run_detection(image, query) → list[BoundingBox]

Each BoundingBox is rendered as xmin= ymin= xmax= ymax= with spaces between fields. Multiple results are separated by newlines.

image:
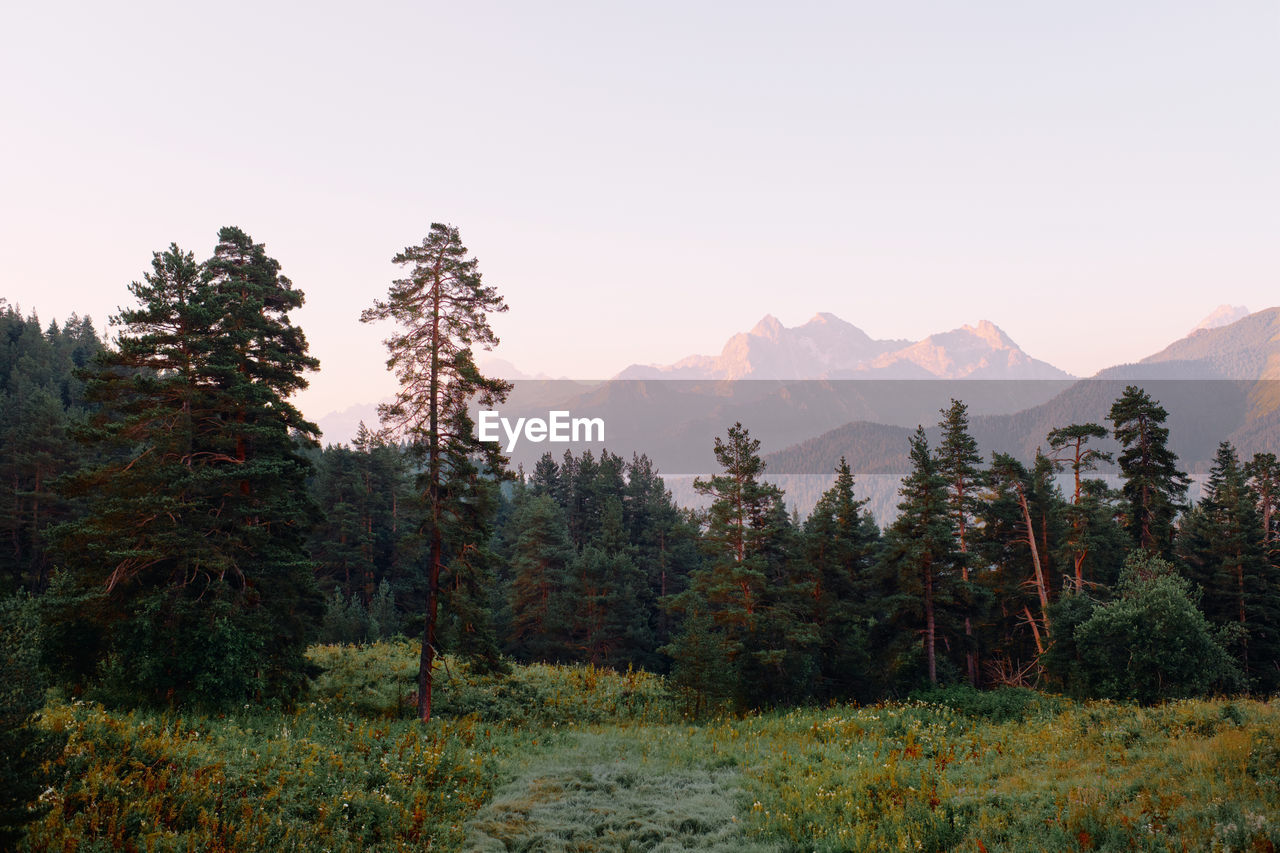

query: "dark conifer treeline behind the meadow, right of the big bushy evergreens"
xmin=296 ymin=387 xmax=1280 ymax=706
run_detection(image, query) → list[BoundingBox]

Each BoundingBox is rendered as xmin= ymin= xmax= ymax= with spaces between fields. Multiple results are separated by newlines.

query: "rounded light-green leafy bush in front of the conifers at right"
xmin=1074 ymin=552 xmax=1243 ymax=702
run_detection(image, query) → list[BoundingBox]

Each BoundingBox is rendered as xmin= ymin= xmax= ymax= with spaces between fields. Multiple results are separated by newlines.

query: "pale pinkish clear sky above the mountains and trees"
xmin=0 ymin=0 xmax=1280 ymax=418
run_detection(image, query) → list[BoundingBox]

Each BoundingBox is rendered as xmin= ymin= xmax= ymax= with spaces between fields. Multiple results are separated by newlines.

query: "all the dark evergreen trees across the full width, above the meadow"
xmin=0 ymin=225 xmax=1280 ymax=829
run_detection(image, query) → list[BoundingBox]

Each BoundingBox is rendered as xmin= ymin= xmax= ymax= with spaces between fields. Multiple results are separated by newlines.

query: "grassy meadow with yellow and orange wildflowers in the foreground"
xmin=27 ymin=643 xmax=1280 ymax=853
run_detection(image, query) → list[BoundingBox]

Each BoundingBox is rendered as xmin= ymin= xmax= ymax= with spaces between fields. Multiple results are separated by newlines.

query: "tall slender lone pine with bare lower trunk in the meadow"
xmin=360 ymin=223 xmax=511 ymax=721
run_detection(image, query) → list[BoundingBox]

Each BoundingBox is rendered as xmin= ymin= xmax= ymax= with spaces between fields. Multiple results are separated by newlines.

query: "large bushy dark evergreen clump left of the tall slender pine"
xmin=52 ymin=228 xmax=320 ymax=703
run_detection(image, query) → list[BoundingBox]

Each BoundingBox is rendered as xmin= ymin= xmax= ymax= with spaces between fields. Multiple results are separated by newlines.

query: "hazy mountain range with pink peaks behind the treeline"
xmin=312 ymin=306 xmax=1280 ymax=511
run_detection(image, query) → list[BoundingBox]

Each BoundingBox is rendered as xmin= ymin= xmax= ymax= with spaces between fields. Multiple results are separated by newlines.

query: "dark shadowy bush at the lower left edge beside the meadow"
xmin=0 ymin=596 xmax=63 ymax=849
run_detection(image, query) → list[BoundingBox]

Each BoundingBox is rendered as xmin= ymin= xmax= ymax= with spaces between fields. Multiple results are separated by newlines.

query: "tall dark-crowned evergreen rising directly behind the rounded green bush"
xmin=1108 ymin=386 xmax=1188 ymax=558
